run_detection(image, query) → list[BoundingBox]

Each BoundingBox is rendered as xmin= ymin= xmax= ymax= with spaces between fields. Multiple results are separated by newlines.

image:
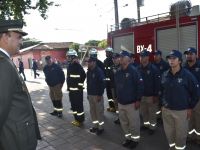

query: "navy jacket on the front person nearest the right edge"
xmin=161 ymin=68 xmax=199 ymax=110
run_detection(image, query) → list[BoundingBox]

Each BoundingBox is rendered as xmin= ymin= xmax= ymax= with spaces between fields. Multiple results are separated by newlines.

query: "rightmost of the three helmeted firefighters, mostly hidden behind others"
xmin=104 ymin=47 xmax=116 ymax=112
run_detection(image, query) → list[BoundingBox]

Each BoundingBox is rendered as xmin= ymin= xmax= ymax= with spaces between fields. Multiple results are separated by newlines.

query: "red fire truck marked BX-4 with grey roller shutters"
xmin=107 ymin=5 xmax=200 ymax=60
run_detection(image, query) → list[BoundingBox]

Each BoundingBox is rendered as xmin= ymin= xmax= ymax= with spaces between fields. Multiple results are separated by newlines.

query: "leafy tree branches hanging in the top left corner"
xmin=0 ymin=0 xmax=59 ymax=20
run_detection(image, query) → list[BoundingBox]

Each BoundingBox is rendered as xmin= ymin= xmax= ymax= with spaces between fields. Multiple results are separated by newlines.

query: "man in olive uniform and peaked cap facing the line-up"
xmin=0 ymin=20 xmax=41 ymax=150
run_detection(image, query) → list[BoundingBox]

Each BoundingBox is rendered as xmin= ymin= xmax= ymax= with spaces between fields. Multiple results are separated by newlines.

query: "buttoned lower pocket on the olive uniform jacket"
xmin=16 ymin=121 xmax=37 ymax=150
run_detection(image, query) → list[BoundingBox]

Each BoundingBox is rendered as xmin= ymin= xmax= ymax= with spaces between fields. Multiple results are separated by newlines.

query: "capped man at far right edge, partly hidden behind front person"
xmin=184 ymin=47 xmax=200 ymax=145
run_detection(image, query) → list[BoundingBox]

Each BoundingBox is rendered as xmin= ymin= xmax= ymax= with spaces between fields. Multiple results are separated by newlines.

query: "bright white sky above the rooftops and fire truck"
xmin=24 ymin=0 xmax=200 ymax=44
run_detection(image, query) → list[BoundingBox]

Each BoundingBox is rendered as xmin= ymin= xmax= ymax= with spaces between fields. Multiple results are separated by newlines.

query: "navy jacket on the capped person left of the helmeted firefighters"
xmin=43 ymin=63 xmax=65 ymax=87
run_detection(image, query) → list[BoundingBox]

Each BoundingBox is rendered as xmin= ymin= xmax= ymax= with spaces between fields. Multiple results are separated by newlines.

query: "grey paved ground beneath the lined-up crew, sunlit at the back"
xmin=22 ymin=70 xmax=199 ymax=150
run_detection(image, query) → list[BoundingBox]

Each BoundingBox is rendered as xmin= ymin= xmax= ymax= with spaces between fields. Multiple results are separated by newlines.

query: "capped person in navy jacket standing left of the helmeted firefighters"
xmin=43 ymin=56 xmax=65 ymax=118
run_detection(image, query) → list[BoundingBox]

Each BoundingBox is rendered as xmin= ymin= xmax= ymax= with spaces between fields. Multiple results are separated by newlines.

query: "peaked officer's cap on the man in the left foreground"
xmin=0 ymin=20 xmax=28 ymax=36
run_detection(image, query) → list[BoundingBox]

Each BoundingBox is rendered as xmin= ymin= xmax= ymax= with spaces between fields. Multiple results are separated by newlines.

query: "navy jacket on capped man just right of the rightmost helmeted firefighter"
xmin=115 ymin=64 xmax=144 ymax=105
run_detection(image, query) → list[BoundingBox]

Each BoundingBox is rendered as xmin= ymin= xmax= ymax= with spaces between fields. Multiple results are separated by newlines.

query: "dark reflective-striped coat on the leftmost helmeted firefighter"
xmin=67 ymin=62 xmax=86 ymax=91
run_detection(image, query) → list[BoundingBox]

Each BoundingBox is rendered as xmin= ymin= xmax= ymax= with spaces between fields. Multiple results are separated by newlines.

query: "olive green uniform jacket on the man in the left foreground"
xmin=0 ymin=51 xmax=41 ymax=150
